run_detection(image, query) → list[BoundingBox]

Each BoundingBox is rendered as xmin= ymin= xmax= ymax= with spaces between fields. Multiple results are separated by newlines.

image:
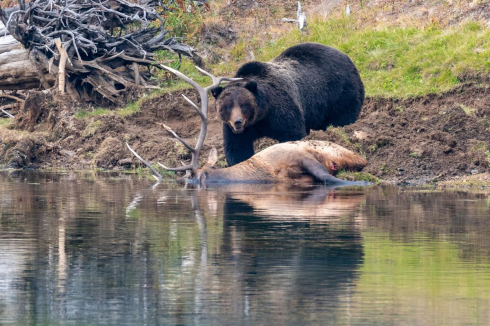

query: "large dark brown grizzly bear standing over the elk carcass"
xmin=212 ymin=43 xmax=364 ymax=166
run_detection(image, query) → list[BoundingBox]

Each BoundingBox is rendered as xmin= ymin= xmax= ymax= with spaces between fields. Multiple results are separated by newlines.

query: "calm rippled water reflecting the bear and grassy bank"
xmin=0 ymin=172 xmax=490 ymax=325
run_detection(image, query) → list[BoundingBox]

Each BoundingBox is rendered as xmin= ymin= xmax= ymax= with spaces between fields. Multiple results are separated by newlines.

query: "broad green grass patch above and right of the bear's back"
xmin=249 ymin=19 xmax=490 ymax=98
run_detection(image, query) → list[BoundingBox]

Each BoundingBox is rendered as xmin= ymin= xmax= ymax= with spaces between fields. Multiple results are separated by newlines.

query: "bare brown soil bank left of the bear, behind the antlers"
xmin=11 ymin=90 xmax=229 ymax=169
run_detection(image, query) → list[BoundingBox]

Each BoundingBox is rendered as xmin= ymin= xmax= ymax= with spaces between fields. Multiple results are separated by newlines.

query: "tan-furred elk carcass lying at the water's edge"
xmin=195 ymin=141 xmax=367 ymax=184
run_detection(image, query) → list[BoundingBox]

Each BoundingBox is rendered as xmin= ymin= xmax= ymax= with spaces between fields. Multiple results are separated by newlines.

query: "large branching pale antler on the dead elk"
xmin=126 ymin=65 xmax=241 ymax=181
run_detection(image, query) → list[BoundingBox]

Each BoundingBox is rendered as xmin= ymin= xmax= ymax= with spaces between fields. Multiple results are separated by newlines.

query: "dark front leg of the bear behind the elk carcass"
xmin=223 ymin=123 xmax=257 ymax=166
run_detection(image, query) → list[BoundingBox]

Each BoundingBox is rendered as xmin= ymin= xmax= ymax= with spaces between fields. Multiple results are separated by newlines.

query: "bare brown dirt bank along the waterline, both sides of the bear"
xmin=0 ymin=85 xmax=490 ymax=184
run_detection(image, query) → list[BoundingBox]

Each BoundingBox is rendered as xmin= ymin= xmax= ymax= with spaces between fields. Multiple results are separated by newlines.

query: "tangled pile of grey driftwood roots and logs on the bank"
xmin=0 ymin=0 xmax=201 ymax=106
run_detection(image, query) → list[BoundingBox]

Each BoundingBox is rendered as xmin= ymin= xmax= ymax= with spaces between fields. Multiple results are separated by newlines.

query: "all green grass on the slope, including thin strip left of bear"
xmin=76 ymin=9 xmax=490 ymax=118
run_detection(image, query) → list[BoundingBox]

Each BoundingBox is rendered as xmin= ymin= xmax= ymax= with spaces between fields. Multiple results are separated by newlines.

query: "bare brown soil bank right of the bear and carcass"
xmin=309 ymin=85 xmax=490 ymax=184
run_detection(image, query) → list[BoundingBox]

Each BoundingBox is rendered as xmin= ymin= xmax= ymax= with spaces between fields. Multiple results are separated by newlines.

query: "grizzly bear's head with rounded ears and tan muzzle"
xmin=211 ymin=80 xmax=258 ymax=134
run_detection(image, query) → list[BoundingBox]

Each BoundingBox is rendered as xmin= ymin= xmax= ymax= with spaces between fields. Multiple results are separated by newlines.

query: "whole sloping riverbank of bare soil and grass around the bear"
xmin=0 ymin=1 xmax=490 ymax=187
